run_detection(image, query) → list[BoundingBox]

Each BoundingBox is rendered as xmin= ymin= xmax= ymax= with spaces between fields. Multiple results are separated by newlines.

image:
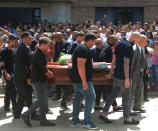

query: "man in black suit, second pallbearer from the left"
xmin=14 ymin=32 xmax=38 ymax=119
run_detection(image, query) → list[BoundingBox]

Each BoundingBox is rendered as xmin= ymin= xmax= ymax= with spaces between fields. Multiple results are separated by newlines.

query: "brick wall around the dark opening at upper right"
xmin=71 ymin=0 xmax=158 ymax=23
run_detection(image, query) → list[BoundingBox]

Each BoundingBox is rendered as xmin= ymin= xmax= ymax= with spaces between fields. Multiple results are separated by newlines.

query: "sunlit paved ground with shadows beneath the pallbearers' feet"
xmin=0 ymin=93 xmax=158 ymax=131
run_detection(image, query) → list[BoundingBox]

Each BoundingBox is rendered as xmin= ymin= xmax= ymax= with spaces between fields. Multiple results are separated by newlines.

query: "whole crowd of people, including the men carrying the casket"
xmin=0 ymin=18 xmax=158 ymax=129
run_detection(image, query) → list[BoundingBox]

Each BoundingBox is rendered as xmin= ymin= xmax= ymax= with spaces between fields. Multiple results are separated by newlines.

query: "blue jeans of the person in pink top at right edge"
xmin=150 ymin=65 xmax=158 ymax=87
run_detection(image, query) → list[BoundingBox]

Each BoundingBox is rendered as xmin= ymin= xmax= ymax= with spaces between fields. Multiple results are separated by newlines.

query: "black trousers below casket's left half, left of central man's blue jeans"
xmin=56 ymin=86 xmax=72 ymax=106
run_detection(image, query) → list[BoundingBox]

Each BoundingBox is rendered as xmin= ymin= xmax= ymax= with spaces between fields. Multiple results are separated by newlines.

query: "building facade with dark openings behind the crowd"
xmin=0 ymin=0 xmax=158 ymax=24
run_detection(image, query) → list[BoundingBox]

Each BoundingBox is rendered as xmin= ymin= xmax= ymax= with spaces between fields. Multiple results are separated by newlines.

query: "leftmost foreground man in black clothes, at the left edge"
xmin=0 ymin=35 xmax=19 ymax=112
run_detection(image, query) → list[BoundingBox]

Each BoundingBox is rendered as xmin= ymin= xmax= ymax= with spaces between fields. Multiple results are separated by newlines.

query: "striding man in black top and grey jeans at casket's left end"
xmin=22 ymin=37 xmax=55 ymax=127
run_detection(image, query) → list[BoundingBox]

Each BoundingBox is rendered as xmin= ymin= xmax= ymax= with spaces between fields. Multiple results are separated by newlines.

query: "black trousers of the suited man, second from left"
xmin=14 ymin=81 xmax=32 ymax=117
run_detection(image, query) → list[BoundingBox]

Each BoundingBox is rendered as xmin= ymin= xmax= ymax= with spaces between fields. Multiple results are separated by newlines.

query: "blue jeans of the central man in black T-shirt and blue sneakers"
xmin=72 ymin=81 xmax=96 ymax=124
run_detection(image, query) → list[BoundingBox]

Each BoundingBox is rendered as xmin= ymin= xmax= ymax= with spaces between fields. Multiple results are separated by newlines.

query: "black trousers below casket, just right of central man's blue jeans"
xmin=94 ymin=86 xmax=117 ymax=106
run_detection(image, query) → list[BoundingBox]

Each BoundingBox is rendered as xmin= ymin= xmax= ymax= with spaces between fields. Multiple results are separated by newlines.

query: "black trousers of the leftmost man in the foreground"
xmin=4 ymin=78 xmax=17 ymax=111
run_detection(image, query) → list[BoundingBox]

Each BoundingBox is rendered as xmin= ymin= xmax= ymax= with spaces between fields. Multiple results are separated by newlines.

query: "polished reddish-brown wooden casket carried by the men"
xmin=47 ymin=62 xmax=112 ymax=85
